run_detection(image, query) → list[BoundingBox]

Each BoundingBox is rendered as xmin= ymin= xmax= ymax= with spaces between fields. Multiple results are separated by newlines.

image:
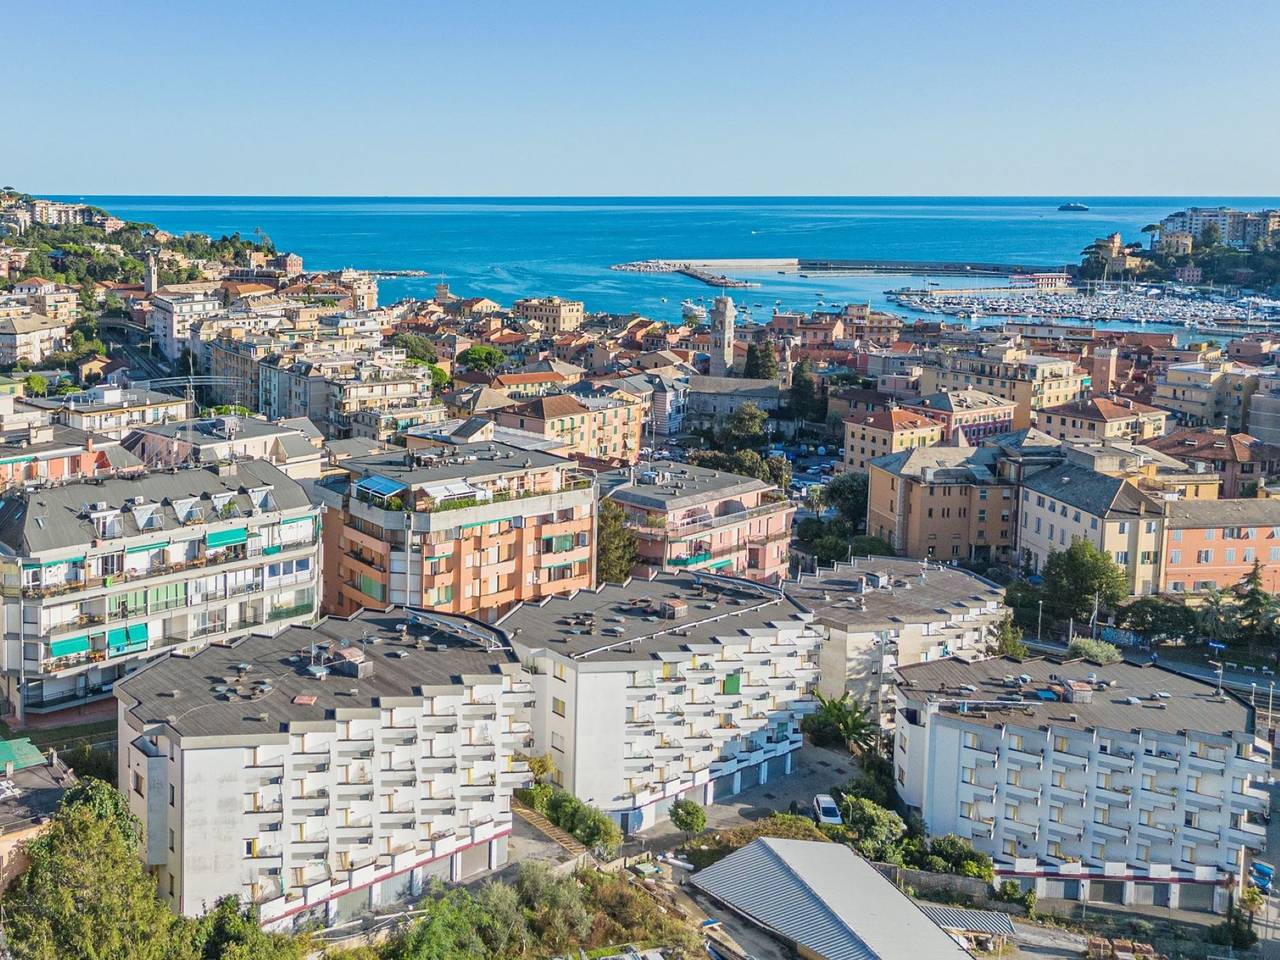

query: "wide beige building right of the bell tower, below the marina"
xmin=920 ymin=342 xmax=1091 ymax=430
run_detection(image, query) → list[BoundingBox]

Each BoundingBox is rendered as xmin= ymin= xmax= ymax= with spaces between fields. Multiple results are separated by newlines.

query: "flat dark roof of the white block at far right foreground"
xmin=896 ymin=657 xmax=1252 ymax=736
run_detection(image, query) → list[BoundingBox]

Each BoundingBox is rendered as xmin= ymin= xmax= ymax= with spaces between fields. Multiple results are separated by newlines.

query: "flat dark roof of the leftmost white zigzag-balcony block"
xmin=115 ymin=607 xmax=516 ymax=739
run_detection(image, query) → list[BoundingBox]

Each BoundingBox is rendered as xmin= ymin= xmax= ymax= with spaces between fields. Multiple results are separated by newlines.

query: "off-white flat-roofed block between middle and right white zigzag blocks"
xmin=783 ymin=557 xmax=1009 ymax=724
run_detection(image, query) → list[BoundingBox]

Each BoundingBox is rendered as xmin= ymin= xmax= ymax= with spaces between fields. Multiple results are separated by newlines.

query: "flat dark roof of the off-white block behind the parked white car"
xmin=782 ymin=557 xmax=1005 ymax=628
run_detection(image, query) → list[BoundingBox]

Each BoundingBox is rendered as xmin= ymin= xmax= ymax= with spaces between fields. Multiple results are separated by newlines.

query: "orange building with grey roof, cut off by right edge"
xmin=1160 ymin=499 xmax=1280 ymax=594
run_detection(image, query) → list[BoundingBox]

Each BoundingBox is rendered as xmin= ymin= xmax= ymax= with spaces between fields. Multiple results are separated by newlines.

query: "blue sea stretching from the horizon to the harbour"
xmin=47 ymin=196 xmax=1280 ymax=320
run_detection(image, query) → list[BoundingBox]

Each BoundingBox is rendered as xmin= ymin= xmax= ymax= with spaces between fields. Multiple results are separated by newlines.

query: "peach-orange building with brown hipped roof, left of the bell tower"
xmin=493 ymin=390 xmax=649 ymax=463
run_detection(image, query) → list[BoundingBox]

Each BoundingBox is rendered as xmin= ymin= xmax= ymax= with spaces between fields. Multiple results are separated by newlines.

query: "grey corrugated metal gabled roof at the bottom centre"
xmin=692 ymin=837 xmax=970 ymax=960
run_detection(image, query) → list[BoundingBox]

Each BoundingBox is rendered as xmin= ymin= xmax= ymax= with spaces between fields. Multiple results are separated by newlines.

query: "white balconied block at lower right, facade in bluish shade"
xmin=893 ymin=658 xmax=1271 ymax=911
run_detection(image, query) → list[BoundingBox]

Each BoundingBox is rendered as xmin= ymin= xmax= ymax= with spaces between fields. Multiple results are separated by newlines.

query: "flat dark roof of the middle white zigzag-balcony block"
xmin=497 ymin=572 xmax=809 ymax=662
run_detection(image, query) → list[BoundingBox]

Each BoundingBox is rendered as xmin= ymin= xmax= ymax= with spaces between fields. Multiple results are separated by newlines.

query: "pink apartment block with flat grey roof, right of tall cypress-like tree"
xmin=600 ymin=461 xmax=795 ymax=584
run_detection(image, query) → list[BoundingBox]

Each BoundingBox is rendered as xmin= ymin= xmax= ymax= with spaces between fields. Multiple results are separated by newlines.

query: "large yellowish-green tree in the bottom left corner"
xmin=4 ymin=800 xmax=189 ymax=960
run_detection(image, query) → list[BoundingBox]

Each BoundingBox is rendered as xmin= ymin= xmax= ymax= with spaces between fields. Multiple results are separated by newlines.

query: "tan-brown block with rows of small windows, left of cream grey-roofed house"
xmin=867 ymin=448 xmax=1018 ymax=562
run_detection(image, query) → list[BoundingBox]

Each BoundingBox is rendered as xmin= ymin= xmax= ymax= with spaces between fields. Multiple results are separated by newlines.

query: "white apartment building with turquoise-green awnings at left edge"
xmin=0 ymin=461 xmax=320 ymax=717
